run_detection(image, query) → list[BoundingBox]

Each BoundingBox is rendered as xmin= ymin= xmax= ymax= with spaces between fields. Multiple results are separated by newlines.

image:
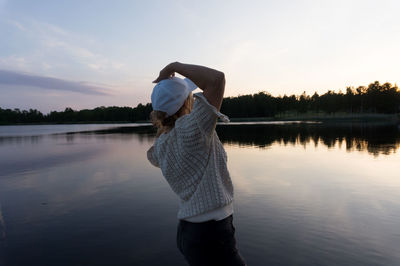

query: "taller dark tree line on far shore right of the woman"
xmin=221 ymin=81 xmax=400 ymax=117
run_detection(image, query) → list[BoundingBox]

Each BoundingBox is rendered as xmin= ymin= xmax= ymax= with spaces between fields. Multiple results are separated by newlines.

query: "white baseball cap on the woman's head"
xmin=151 ymin=77 xmax=197 ymax=117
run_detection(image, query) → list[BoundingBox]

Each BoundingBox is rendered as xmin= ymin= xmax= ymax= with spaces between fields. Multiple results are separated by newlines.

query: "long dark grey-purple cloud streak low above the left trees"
xmin=0 ymin=70 xmax=109 ymax=95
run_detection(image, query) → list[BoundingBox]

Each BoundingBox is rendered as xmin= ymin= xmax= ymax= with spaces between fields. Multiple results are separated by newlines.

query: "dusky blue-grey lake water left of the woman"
xmin=0 ymin=134 xmax=184 ymax=266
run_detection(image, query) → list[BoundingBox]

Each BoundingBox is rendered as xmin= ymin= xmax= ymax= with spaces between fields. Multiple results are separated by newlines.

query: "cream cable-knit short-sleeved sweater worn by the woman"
xmin=147 ymin=93 xmax=233 ymax=219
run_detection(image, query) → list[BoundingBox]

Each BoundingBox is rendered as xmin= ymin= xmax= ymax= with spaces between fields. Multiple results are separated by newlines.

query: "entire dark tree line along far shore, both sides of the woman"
xmin=0 ymin=81 xmax=400 ymax=124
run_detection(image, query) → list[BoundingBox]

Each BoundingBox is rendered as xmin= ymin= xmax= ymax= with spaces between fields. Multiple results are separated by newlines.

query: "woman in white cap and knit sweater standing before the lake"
xmin=147 ymin=62 xmax=245 ymax=265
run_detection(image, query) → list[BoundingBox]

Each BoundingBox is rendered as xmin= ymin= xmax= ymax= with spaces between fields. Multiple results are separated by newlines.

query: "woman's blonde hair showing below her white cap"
xmin=150 ymin=93 xmax=193 ymax=137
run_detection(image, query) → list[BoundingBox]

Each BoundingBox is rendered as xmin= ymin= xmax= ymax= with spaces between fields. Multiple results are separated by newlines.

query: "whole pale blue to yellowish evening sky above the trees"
xmin=0 ymin=0 xmax=400 ymax=113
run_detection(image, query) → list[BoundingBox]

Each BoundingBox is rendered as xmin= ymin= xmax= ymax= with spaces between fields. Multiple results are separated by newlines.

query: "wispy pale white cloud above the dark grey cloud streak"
xmin=0 ymin=19 xmax=126 ymax=81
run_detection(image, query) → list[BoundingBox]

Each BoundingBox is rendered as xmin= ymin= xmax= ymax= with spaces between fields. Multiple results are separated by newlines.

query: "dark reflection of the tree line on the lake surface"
xmin=65 ymin=123 xmax=400 ymax=156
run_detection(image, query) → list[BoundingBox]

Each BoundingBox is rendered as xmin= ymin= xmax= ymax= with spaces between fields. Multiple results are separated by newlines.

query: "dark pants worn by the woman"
xmin=176 ymin=215 xmax=245 ymax=266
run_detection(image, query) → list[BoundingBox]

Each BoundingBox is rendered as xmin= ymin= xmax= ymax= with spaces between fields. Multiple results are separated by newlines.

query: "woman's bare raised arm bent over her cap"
xmin=153 ymin=62 xmax=225 ymax=111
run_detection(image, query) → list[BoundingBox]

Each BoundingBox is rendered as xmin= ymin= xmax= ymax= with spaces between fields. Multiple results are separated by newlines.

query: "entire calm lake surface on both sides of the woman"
xmin=0 ymin=122 xmax=400 ymax=265
